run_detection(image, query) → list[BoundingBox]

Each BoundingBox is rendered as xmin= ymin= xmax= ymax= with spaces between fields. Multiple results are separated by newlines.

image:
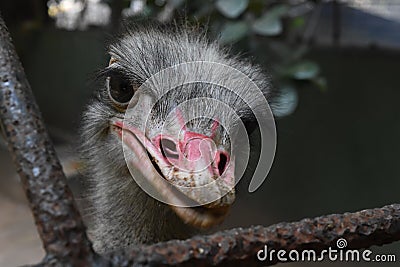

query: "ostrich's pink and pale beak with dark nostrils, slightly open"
xmin=111 ymin=121 xmax=235 ymax=228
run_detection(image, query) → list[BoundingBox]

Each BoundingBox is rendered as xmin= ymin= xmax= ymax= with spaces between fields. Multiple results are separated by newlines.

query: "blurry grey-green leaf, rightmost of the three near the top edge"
xmin=252 ymin=5 xmax=289 ymax=36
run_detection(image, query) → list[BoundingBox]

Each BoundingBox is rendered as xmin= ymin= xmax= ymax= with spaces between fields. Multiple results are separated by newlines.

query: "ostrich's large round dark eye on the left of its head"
xmin=107 ymin=75 xmax=135 ymax=105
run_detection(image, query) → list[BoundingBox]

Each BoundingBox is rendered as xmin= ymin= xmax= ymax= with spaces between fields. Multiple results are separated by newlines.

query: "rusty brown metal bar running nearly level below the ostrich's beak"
xmin=109 ymin=204 xmax=400 ymax=266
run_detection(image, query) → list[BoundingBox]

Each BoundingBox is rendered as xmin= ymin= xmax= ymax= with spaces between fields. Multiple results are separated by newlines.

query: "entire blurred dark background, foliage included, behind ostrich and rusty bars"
xmin=0 ymin=0 xmax=400 ymax=266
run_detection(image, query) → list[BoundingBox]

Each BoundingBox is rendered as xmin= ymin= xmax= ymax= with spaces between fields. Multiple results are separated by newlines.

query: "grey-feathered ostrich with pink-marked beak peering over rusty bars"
xmin=81 ymin=26 xmax=271 ymax=253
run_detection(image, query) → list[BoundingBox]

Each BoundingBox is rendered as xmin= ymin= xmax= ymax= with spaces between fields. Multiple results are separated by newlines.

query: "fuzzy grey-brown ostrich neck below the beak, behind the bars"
xmin=85 ymin=169 xmax=193 ymax=252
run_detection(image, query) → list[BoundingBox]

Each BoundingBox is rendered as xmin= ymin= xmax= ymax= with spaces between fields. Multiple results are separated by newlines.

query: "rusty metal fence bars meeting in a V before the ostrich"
xmin=0 ymin=14 xmax=400 ymax=266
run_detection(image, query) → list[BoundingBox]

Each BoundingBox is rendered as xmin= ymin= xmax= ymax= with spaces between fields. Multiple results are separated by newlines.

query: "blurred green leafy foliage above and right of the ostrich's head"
xmin=126 ymin=0 xmax=327 ymax=116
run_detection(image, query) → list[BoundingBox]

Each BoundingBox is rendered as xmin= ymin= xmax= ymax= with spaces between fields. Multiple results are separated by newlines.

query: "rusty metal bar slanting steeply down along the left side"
xmin=0 ymin=12 xmax=95 ymax=263
